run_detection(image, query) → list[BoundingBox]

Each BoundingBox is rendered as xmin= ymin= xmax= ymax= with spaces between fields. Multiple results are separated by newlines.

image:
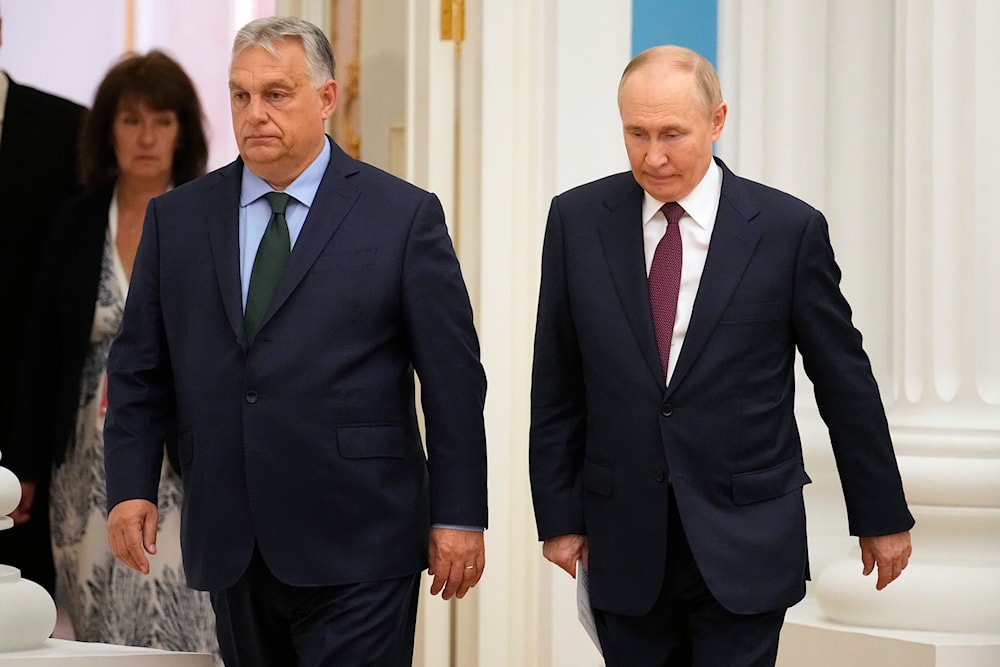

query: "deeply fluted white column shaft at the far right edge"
xmin=890 ymin=0 xmax=1000 ymax=512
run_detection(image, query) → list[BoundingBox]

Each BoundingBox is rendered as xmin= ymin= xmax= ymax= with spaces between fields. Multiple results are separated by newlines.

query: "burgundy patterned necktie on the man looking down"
xmin=649 ymin=201 xmax=684 ymax=378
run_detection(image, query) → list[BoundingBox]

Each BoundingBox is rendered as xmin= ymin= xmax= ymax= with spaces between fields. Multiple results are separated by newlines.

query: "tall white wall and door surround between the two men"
xmin=468 ymin=0 xmax=631 ymax=667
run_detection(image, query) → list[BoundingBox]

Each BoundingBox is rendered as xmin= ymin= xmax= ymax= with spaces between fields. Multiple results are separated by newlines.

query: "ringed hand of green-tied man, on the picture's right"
xmin=427 ymin=528 xmax=486 ymax=600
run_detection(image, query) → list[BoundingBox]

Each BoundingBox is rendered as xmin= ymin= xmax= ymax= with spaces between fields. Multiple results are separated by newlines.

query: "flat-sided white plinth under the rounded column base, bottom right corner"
xmin=777 ymin=596 xmax=1000 ymax=667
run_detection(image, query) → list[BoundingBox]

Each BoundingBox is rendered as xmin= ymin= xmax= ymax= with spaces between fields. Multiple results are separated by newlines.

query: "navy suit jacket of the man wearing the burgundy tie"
xmin=530 ymin=162 xmax=913 ymax=614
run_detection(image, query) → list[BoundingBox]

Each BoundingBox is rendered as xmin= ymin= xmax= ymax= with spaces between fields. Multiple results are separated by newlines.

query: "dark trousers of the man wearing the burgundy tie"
xmin=594 ymin=492 xmax=785 ymax=667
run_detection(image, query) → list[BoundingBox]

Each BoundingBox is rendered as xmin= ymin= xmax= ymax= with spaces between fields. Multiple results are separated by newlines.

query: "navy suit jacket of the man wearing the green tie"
xmin=105 ymin=144 xmax=486 ymax=590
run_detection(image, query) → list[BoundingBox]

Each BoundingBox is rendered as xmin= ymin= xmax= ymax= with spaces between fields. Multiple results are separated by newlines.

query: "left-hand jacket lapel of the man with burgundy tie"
xmin=597 ymin=174 xmax=663 ymax=385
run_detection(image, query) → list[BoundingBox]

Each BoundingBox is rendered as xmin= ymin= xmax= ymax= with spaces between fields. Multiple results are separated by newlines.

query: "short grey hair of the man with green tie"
xmin=232 ymin=16 xmax=336 ymax=88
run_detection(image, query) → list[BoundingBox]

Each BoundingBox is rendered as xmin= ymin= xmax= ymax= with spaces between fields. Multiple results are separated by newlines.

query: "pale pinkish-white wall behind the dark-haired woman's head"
xmin=0 ymin=0 xmax=274 ymax=169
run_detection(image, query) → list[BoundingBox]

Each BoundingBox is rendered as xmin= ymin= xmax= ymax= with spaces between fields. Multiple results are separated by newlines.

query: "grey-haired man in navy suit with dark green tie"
xmin=104 ymin=18 xmax=486 ymax=667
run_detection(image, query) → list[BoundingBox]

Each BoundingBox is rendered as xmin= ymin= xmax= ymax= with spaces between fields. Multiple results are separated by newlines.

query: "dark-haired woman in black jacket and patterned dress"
xmin=8 ymin=51 xmax=218 ymax=654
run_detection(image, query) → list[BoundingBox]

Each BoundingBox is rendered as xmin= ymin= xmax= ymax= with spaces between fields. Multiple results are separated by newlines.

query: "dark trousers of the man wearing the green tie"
xmin=212 ymin=549 xmax=420 ymax=667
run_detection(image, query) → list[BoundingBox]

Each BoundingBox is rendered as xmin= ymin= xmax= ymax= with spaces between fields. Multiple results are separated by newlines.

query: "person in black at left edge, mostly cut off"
xmin=0 ymin=13 xmax=87 ymax=593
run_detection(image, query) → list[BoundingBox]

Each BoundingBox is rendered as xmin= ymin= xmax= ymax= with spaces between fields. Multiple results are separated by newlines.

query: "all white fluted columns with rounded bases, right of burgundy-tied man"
xmin=718 ymin=0 xmax=1000 ymax=632
